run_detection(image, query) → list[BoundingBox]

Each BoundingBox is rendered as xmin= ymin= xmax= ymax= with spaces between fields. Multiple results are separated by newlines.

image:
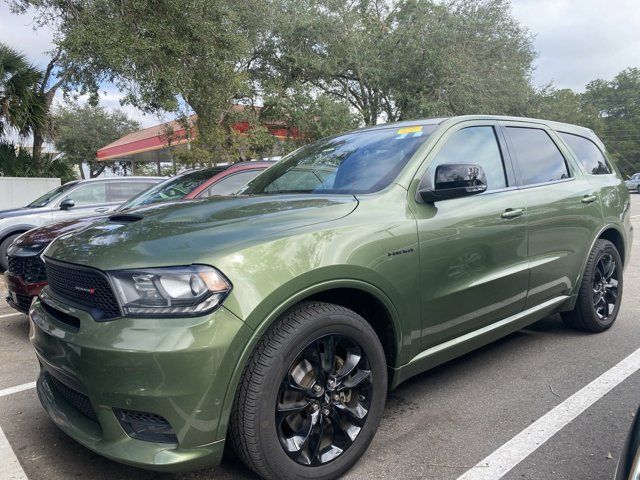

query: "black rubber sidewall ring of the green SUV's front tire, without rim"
xmin=256 ymin=313 xmax=387 ymax=479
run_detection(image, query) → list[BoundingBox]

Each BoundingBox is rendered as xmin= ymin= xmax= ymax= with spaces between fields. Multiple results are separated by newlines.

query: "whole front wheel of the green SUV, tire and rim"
xmin=230 ymin=302 xmax=387 ymax=480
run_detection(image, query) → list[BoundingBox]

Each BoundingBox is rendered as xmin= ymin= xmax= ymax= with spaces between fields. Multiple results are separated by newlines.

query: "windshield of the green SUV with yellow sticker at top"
xmin=237 ymin=125 xmax=436 ymax=195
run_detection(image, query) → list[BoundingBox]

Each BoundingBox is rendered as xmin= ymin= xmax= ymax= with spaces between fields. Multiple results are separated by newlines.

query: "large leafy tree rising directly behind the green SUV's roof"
xmin=255 ymin=0 xmax=534 ymax=124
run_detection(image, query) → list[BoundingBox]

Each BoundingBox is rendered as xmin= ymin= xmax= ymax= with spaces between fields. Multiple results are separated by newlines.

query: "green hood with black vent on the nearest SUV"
xmin=45 ymin=195 xmax=358 ymax=270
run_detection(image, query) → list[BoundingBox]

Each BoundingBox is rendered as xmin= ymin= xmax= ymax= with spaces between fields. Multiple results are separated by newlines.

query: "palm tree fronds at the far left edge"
xmin=0 ymin=43 xmax=47 ymax=137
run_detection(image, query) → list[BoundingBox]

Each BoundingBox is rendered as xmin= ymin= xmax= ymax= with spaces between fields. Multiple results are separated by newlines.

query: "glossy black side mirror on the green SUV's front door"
xmin=418 ymin=163 xmax=487 ymax=203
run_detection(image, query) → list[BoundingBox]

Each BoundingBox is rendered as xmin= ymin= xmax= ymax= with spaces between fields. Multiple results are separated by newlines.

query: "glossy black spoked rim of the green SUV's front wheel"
xmin=275 ymin=335 xmax=373 ymax=466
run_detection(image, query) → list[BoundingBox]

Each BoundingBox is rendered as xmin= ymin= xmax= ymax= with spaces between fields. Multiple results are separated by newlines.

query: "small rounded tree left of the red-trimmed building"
xmin=53 ymin=103 xmax=140 ymax=178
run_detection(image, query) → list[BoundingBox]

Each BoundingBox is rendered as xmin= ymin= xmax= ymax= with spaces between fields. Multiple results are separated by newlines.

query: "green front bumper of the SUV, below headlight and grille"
xmin=30 ymin=288 xmax=251 ymax=472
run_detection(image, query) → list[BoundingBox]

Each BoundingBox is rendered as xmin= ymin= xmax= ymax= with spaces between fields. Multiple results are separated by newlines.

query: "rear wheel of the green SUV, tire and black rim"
xmin=561 ymin=239 xmax=623 ymax=333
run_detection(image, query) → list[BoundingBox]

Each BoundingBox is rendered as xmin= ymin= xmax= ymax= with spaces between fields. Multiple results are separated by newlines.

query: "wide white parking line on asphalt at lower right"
xmin=458 ymin=349 xmax=640 ymax=480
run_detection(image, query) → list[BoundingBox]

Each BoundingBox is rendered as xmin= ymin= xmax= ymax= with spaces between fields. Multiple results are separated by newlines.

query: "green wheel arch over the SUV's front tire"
xmin=217 ymin=279 xmax=402 ymax=439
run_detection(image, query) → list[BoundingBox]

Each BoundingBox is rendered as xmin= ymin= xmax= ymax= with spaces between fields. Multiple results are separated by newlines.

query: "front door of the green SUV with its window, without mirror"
xmin=413 ymin=122 xmax=529 ymax=349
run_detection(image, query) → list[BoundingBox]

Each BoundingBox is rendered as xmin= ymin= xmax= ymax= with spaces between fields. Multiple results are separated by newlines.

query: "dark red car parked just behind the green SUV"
xmin=5 ymin=161 xmax=274 ymax=313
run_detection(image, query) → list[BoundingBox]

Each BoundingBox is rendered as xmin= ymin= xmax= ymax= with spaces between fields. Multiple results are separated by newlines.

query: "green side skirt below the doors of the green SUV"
xmin=390 ymin=295 xmax=571 ymax=389
